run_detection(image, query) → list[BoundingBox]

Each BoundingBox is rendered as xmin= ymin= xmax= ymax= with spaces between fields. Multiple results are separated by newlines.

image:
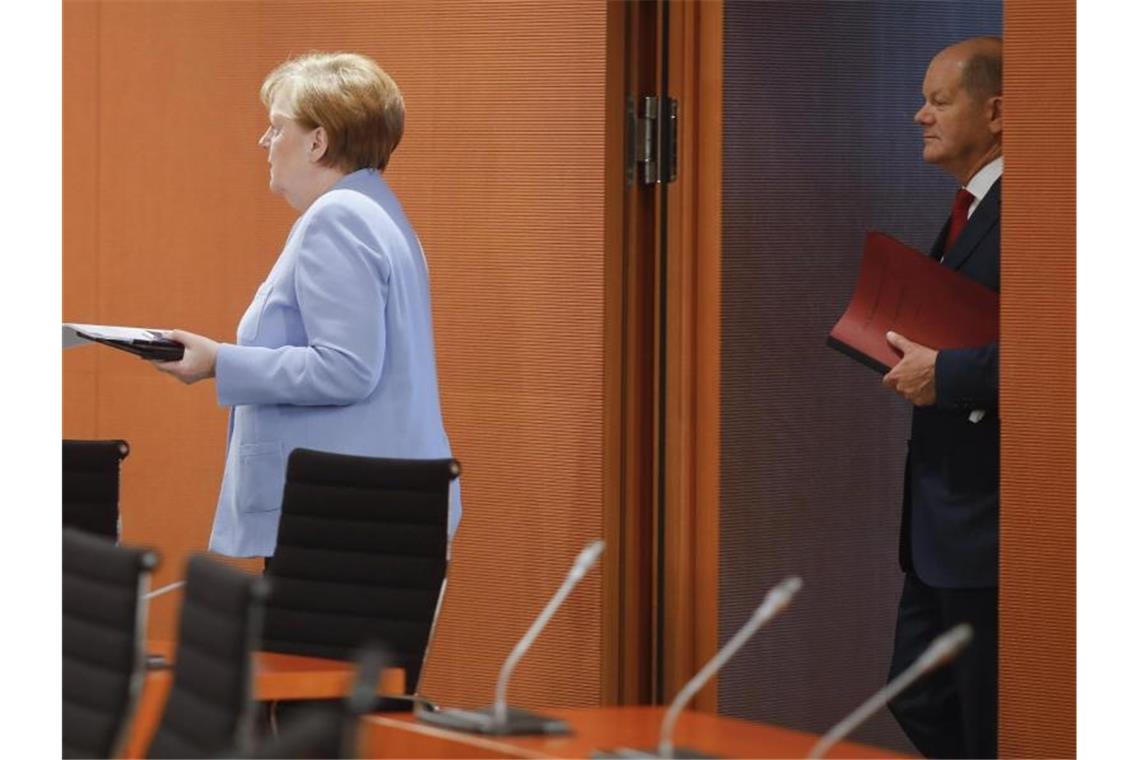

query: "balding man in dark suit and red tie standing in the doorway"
xmin=882 ymin=38 xmax=1002 ymax=758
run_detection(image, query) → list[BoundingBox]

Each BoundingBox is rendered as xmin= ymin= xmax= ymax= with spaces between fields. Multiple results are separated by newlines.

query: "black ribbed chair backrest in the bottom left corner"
xmin=63 ymin=528 xmax=158 ymax=758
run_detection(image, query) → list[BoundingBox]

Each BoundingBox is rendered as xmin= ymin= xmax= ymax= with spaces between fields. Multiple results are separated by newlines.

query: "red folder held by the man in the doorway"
xmin=828 ymin=230 xmax=998 ymax=373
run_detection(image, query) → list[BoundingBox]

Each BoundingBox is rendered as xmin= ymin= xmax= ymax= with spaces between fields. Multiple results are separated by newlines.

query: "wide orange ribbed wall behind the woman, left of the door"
xmin=64 ymin=0 xmax=605 ymax=705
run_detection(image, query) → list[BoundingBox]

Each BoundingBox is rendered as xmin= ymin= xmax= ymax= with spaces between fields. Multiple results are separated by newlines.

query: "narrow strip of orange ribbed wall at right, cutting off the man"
xmin=999 ymin=0 xmax=1076 ymax=758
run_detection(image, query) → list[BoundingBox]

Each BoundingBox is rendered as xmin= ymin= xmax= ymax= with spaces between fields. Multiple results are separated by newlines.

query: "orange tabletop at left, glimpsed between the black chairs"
xmin=123 ymin=640 xmax=405 ymax=758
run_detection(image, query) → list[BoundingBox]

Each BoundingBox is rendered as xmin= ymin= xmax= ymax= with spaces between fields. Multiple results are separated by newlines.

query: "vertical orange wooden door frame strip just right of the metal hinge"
xmin=662 ymin=0 xmax=724 ymax=712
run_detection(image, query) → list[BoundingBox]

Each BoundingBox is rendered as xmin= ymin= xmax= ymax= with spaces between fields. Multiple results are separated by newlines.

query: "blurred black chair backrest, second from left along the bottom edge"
xmin=147 ymin=554 xmax=268 ymax=758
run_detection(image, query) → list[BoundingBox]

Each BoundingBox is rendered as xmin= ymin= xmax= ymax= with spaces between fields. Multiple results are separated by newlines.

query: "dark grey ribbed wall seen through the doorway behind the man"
xmin=718 ymin=0 xmax=1002 ymax=750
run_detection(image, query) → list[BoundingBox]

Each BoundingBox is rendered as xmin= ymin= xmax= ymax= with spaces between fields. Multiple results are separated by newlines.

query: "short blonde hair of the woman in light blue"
xmin=261 ymin=52 xmax=404 ymax=172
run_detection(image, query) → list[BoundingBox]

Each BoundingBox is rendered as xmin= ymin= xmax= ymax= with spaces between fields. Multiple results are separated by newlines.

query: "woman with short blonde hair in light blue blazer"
xmin=156 ymin=54 xmax=461 ymax=557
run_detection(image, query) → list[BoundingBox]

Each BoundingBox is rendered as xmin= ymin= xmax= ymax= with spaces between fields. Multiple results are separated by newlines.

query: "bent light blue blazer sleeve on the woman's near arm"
xmin=215 ymin=203 xmax=390 ymax=406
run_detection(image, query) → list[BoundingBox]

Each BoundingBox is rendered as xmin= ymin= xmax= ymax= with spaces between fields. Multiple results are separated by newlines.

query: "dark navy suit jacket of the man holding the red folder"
xmin=899 ymin=179 xmax=1001 ymax=588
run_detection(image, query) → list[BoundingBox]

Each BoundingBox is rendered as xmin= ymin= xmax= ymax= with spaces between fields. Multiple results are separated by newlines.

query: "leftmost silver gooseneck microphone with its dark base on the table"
xmin=416 ymin=540 xmax=605 ymax=735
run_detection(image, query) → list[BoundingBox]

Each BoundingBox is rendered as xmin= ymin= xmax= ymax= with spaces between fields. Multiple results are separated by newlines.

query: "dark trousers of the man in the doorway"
xmin=889 ymin=573 xmax=998 ymax=758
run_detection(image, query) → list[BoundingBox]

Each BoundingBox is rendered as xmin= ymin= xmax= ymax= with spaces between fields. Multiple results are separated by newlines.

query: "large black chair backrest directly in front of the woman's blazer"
xmin=262 ymin=449 xmax=459 ymax=694
